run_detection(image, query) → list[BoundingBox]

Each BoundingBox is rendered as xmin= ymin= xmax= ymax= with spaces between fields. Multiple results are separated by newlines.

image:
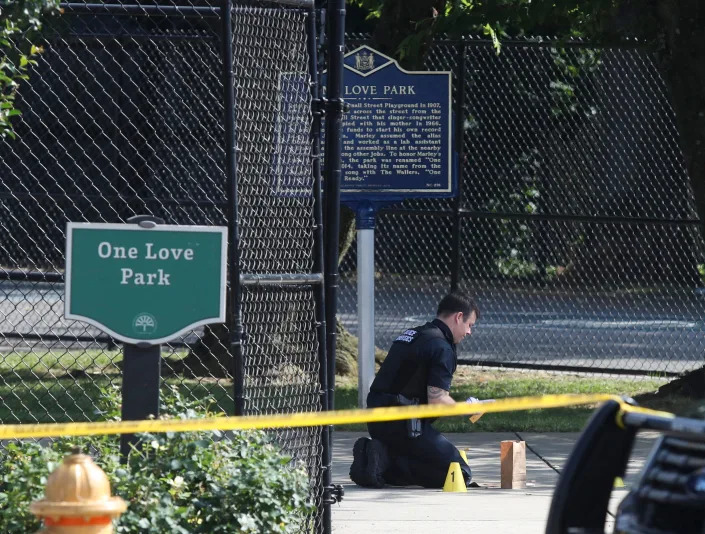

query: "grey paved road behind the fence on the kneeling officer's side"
xmin=339 ymin=281 xmax=705 ymax=372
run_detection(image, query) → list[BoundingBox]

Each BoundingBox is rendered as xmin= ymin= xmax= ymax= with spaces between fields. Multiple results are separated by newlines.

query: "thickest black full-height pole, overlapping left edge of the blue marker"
xmin=323 ymin=0 xmax=345 ymax=534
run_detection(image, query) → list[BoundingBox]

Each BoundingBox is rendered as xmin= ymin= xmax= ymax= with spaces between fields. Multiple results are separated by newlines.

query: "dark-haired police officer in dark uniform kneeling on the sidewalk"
xmin=350 ymin=292 xmax=480 ymax=488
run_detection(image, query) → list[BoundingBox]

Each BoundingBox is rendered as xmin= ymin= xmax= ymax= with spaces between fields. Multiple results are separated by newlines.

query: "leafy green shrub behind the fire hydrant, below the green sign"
xmin=0 ymin=390 xmax=314 ymax=534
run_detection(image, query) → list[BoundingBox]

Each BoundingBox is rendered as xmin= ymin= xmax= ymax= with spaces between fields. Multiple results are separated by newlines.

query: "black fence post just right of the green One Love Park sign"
xmin=221 ymin=0 xmax=245 ymax=415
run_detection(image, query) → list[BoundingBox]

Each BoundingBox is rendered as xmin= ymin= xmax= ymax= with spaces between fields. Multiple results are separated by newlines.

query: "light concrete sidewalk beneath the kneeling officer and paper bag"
xmin=333 ymin=432 xmax=660 ymax=534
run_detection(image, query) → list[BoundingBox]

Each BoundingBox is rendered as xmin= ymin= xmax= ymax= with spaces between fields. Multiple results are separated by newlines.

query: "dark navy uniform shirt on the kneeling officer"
xmin=368 ymin=319 xmax=458 ymax=404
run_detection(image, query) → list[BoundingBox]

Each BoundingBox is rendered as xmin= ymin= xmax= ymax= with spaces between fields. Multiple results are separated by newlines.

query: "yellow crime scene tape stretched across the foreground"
xmin=0 ymin=394 xmax=675 ymax=439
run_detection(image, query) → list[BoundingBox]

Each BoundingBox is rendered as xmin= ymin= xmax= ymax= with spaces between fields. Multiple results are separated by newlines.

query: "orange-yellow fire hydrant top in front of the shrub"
xmin=29 ymin=449 xmax=127 ymax=534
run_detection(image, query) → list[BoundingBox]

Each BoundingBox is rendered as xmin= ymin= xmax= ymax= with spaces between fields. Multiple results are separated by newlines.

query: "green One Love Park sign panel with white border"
xmin=64 ymin=222 xmax=227 ymax=345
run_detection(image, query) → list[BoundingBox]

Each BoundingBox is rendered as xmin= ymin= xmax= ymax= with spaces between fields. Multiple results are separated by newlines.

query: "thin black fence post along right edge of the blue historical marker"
xmin=450 ymin=40 xmax=466 ymax=291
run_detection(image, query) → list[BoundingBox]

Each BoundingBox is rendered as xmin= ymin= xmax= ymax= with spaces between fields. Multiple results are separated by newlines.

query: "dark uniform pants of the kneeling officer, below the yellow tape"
xmin=367 ymin=419 xmax=472 ymax=488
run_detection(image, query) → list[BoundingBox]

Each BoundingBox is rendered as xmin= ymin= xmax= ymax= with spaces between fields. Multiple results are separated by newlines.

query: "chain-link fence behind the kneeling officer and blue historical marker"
xmin=340 ymin=39 xmax=705 ymax=373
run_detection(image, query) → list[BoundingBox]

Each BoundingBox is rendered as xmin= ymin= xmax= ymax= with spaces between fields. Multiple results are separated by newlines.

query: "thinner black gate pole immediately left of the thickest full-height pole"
xmin=308 ymin=9 xmax=333 ymax=533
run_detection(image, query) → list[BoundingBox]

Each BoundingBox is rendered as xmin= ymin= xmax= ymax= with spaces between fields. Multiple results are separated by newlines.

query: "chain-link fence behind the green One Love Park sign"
xmin=0 ymin=1 xmax=325 ymax=532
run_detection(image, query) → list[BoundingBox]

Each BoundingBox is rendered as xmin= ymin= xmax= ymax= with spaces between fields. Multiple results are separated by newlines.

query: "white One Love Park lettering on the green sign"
xmin=98 ymin=241 xmax=194 ymax=286
